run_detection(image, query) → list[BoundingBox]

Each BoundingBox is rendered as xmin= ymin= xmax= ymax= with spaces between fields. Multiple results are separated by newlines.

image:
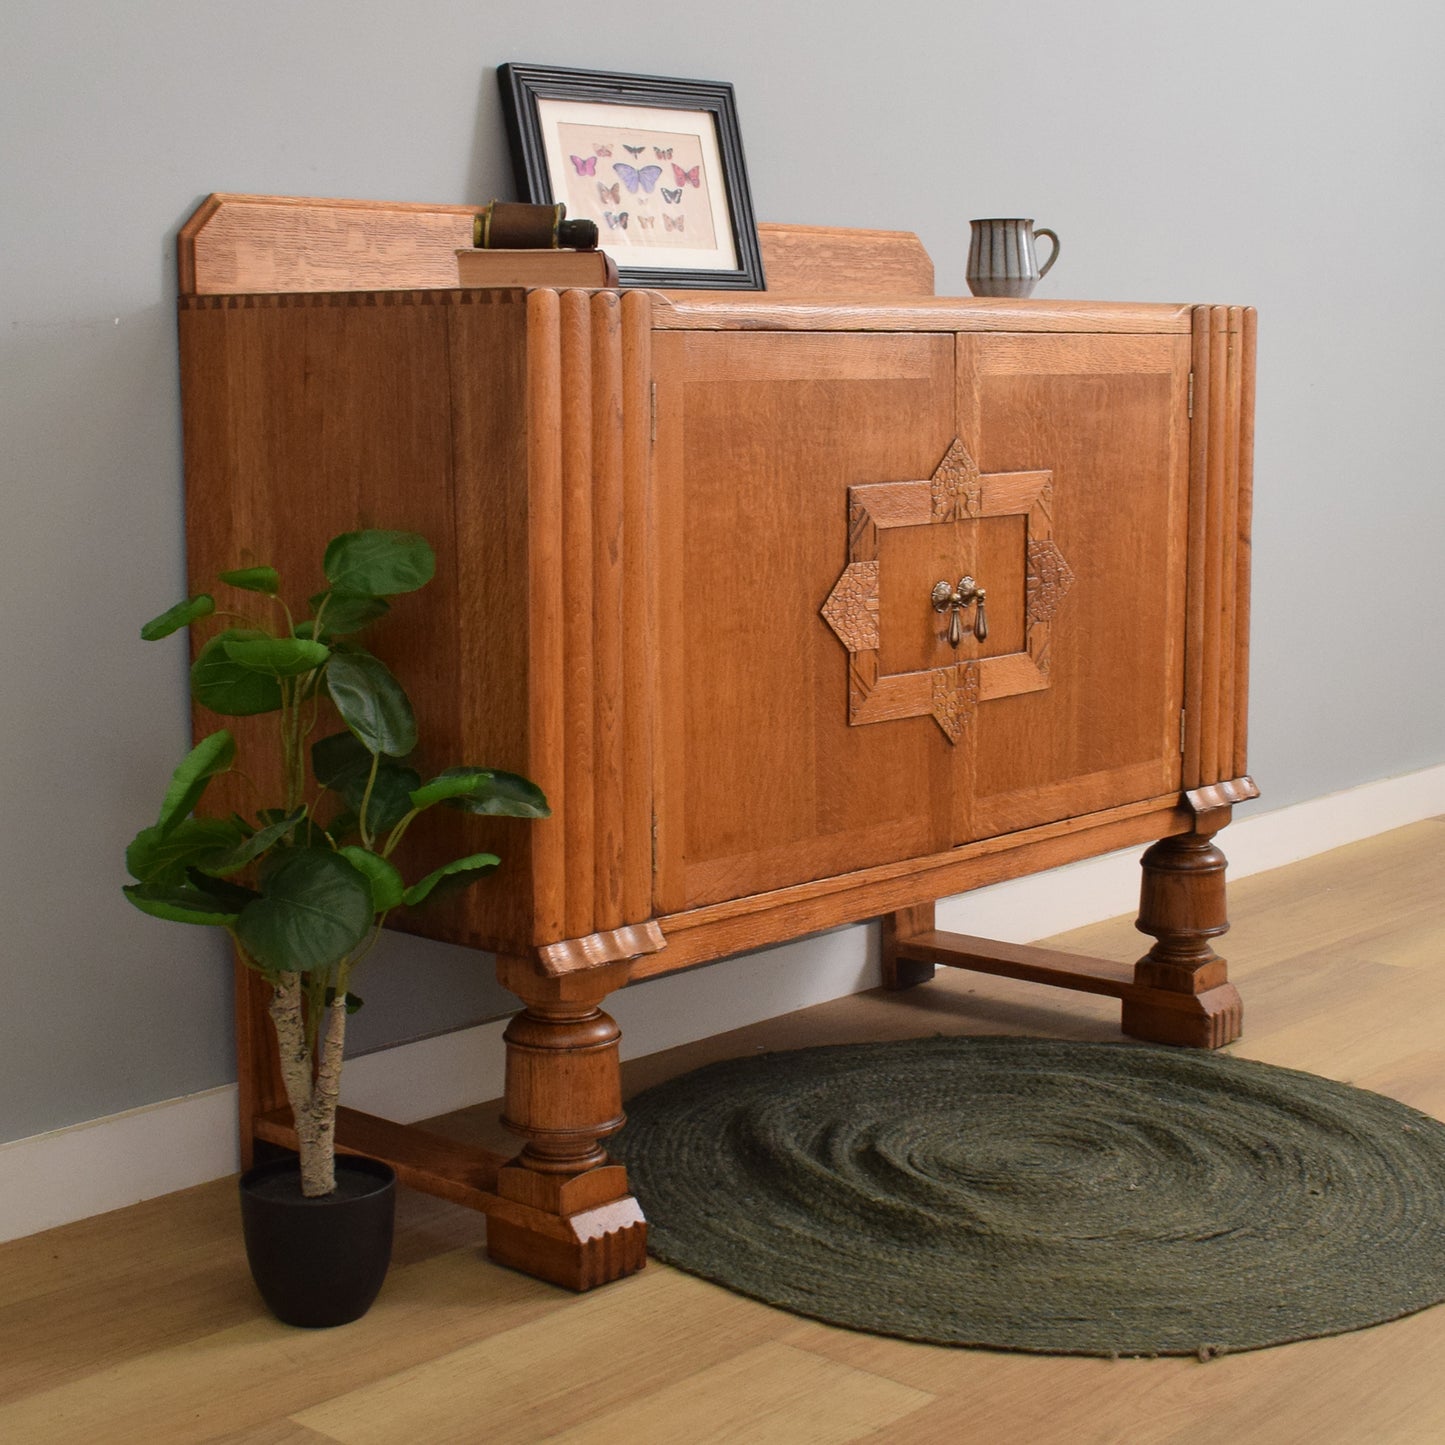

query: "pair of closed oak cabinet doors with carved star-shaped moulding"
xmin=655 ymin=332 xmax=1188 ymax=913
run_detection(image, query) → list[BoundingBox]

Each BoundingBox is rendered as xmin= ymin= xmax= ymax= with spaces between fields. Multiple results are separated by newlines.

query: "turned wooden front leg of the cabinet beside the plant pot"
xmin=487 ymin=958 xmax=647 ymax=1290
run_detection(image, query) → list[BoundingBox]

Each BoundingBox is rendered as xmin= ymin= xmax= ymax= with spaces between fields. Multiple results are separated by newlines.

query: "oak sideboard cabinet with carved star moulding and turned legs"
xmin=181 ymin=198 xmax=1256 ymax=1287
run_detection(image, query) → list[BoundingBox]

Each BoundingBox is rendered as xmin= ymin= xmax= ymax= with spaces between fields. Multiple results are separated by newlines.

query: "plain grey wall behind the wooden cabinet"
xmin=0 ymin=0 xmax=1445 ymax=1140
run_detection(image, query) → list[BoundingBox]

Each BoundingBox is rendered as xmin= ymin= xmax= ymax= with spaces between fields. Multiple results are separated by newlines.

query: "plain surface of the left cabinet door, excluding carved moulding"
xmin=655 ymin=332 xmax=959 ymax=913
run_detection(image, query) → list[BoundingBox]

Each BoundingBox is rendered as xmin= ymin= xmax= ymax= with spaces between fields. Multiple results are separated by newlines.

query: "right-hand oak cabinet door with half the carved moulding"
xmin=954 ymin=334 xmax=1189 ymax=842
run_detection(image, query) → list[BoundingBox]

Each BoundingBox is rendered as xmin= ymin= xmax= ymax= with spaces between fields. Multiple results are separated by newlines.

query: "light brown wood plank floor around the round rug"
xmin=0 ymin=819 xmax=1445 ymax=1445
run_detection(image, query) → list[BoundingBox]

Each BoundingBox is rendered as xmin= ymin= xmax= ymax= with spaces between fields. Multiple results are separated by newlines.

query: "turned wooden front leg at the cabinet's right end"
xmin=1123 ymin=832 xmax=1243 ymax=1049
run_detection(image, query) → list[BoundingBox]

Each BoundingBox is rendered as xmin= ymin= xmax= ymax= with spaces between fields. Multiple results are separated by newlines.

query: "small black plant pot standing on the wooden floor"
xmin=241 ymin=1155 xmax=396 ymax=1329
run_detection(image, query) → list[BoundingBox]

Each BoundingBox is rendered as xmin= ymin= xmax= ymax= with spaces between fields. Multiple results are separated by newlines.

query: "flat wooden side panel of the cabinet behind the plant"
xmin=181 ymin=292 xmax=543 ymax=946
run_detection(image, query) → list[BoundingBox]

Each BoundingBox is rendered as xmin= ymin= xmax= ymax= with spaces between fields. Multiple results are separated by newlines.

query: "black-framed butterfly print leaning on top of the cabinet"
xmin=497 ymin=65 xmax=763 ymax=290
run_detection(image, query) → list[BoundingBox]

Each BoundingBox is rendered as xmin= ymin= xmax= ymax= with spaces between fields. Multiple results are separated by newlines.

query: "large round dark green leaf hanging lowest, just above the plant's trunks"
xmin=236 ymin=848 xmax=374 ymax=974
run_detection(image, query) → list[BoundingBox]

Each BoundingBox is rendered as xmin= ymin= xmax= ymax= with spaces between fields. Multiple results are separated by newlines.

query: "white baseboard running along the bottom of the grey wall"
xmin=0 ymin=764 xmax=1445 ymax=1240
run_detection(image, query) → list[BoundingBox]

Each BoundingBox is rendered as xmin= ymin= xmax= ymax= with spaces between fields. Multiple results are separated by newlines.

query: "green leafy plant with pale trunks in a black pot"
xmin=124 ymin=530 xmax=549 ymax=1325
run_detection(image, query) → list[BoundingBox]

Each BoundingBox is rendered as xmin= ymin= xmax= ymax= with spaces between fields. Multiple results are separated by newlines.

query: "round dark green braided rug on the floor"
xmin=614 ymin=1038 xmax=1445 ymax=1358
